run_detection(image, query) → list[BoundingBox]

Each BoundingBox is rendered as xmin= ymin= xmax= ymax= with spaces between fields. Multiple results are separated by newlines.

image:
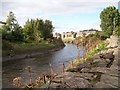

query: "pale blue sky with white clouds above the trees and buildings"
xmin=0 ymin=0 xmax=119 ymax=33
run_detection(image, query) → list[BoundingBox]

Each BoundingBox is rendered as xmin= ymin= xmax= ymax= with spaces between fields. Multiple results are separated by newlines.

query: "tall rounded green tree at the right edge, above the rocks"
xmin=100 ymin=6 xmax=120 ymax=37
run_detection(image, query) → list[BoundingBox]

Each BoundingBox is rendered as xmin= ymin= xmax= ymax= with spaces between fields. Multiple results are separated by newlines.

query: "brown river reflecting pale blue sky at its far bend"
xmin=2 ymin=44 xmax=82 ymax=88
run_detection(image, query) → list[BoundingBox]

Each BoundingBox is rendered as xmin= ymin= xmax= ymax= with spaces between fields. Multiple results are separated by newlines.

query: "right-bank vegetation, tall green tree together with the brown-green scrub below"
xmin=74 ymin=6 xmax=120 ymax=63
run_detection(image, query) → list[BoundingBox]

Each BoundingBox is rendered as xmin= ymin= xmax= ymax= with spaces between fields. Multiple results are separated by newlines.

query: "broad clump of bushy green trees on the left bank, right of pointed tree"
xmin=23 ymin=19 xmax=53 ymax=42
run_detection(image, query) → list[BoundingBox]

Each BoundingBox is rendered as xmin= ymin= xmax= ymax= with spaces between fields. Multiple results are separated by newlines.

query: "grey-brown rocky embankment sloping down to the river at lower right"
xmin=42 ymin=37 xmax=120 ymax=88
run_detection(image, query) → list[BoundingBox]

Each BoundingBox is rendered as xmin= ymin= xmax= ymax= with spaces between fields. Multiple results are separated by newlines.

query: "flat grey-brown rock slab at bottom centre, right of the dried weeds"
xmin=49 ymin=73 xmax=92 ymax=88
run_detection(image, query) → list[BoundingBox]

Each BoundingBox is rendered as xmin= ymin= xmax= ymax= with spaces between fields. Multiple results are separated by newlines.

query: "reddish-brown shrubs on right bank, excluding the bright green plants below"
xmin=74 ymin=33 xmax=102 ymax=60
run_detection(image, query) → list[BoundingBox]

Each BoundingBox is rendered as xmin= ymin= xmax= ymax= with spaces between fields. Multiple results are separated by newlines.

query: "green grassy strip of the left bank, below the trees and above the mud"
xmin=2 ymin=39 xmax=64 ymax=57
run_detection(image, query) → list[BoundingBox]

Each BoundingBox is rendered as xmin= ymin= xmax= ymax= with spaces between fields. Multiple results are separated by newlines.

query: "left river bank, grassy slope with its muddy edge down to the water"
xmin=2 ymin=41 xmax=65 ymax=62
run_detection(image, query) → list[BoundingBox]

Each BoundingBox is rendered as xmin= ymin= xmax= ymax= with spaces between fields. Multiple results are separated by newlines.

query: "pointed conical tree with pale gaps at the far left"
xmin=2 ymin=11 xmax=23 ymax=41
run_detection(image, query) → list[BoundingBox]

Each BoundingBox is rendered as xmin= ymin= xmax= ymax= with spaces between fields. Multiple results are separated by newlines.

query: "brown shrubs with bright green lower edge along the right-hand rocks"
xmin=73 ymin=34 xmax=104 ymax=65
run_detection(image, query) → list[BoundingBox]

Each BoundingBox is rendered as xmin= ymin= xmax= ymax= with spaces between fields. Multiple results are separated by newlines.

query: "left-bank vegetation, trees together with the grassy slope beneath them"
xmin=0 ymin=12 xmax=64 ymax=56
